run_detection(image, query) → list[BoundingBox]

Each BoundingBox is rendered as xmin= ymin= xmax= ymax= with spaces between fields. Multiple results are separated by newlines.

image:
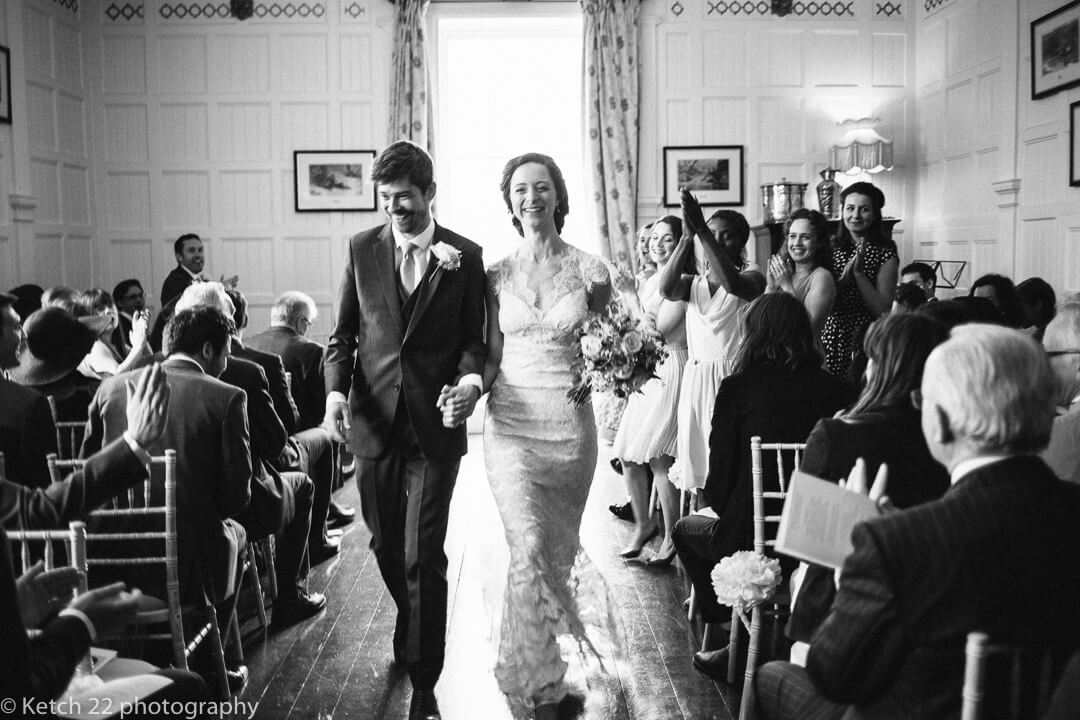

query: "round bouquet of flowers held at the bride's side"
xmin=567 ymin=303 xmax=667 ymax=405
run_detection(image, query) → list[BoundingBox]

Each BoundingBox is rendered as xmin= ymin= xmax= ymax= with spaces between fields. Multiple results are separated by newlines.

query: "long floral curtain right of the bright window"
xmin=580 ymin=0 xmax=640 ymax=272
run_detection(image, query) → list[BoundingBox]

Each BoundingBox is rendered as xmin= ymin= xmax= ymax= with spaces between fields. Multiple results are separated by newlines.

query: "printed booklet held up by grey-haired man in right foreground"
xmin=777 ymin=471 xmax=878 ymax=569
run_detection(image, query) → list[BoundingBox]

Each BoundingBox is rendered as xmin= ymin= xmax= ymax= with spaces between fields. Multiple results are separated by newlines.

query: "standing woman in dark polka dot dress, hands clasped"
xmin=821 ymin=182 xmax=900 ymax=381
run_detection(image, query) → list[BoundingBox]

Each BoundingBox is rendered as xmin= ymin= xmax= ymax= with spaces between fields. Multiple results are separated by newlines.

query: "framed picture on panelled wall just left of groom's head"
xmin=293 ymin=150 xmax=376 ymax=213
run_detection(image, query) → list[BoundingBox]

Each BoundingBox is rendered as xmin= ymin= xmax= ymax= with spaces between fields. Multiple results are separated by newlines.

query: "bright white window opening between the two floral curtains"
xmin=429 ymin=2 xmax=599 ymax=264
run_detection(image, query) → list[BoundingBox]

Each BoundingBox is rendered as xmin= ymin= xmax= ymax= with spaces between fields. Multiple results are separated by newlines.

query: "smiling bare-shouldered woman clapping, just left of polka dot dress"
xmin=765 ymin=207 xmax=836 ymax=338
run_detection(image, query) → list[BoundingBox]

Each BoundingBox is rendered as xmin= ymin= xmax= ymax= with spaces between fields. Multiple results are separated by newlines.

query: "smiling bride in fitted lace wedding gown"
xmin=440 ymin=153 xmax=611 ymax=720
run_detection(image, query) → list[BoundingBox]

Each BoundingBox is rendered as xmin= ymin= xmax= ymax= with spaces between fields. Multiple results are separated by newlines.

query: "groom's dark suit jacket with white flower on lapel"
xmin=325 ymin=225 xmax=487 ymax=461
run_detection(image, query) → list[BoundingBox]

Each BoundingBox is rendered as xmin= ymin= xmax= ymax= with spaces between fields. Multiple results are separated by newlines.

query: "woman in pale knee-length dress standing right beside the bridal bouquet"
xmin=611 ymin=215 xmax=693 ymax=565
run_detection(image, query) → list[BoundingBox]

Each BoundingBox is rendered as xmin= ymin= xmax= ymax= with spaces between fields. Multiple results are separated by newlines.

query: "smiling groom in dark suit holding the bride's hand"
xmin=323 ymin=141 xmax=486 ymax=720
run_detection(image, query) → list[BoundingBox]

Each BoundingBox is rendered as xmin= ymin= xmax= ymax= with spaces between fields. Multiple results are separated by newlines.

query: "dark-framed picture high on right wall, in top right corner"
xmin=1031 ymin=0 xmax=1080 ymax=100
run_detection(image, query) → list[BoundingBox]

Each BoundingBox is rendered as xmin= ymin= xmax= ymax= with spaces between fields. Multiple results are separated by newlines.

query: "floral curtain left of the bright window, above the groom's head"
xmin=388 ymin=0 xmax=434 ymax=152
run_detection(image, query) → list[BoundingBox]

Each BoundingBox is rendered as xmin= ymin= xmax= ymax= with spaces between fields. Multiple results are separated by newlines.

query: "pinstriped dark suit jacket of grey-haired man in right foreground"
xmin=807 ymin=457 xmax=1080 ymax=720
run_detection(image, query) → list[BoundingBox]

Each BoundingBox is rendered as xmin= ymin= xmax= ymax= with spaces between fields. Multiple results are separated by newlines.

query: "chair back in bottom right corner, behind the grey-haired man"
xmin=960 ymin=631 xmax=1076 ymax=720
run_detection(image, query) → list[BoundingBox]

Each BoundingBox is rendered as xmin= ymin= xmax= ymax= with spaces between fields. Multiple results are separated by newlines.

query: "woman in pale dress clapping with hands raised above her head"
xmin=658 ymin=190 xmax=765 ymax=490
